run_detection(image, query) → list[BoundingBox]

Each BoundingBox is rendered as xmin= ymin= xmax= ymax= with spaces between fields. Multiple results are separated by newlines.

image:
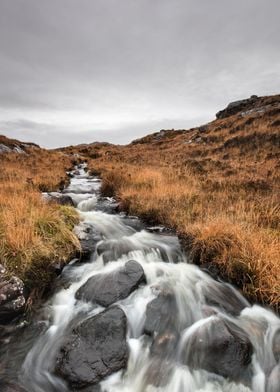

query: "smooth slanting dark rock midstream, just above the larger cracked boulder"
xmin=75 ymin=261 xmax=146 ymax=307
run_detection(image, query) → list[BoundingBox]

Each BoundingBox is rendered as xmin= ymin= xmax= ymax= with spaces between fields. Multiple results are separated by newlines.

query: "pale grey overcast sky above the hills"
xmin=0 ymin=0 xmax=280 ymax=147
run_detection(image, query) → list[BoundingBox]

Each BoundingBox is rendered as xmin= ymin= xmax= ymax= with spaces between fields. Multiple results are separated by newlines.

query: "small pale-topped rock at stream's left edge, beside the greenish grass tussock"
xmin=74 ymin=222 xmax=102 ymax=261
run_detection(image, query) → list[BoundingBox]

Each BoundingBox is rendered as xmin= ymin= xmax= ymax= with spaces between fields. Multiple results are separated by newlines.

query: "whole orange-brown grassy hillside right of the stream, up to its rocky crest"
xmin=60 ymin=95 xmax=280 ymax=308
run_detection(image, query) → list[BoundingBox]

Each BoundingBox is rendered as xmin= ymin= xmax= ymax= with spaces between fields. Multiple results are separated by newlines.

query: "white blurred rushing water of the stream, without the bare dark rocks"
xmin=20 ymin=167 xmax=280 ymax=392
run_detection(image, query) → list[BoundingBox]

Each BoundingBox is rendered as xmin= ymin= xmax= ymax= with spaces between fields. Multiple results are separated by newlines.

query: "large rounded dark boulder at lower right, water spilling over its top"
xmin=183 ymin=316 xmax=253 ymax=380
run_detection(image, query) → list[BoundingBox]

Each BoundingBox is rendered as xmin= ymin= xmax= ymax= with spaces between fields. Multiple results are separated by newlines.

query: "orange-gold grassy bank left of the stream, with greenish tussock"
xmin=0 ymin=149 xmax=79 ymax=292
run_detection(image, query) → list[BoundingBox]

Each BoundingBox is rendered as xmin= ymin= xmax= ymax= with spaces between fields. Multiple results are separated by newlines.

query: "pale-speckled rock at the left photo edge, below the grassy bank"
xmin=0 ymin=265 xmax=25 ymax=324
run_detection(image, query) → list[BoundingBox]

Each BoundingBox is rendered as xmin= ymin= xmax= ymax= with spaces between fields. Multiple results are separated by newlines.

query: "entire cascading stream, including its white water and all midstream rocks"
xmin=0 ymin=164 xmax=280 ymax=392
